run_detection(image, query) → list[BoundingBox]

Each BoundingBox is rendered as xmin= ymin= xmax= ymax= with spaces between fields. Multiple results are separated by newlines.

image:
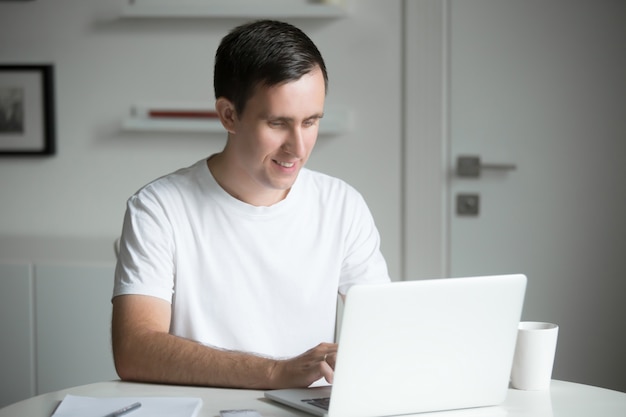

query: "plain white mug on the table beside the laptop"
xmin=511 ymin=321 xmax=559 ymax=390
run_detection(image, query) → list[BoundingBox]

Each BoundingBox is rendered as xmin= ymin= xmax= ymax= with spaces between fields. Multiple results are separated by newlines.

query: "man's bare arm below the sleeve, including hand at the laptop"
xmin=112 ymin=295 xmax=337 ymax=389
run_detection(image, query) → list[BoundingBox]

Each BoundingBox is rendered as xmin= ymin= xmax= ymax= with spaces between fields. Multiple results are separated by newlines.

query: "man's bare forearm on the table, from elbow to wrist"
xmin=114 ymin=331 xmax=277 ymax=389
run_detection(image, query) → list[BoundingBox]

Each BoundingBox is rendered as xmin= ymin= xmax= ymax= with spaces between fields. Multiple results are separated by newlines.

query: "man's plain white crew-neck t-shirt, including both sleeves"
xmin=113 ymin=160 xmax=389 ymax=357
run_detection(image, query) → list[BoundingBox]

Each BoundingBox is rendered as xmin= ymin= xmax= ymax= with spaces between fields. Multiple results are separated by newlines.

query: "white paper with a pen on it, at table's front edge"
xmin=52 ymin=395 xmax=202 ymax=417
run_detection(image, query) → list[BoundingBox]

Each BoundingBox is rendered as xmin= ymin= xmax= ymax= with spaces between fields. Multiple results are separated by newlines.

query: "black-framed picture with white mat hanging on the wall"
xmin=0 ymin=65 xmax=55 ymax=156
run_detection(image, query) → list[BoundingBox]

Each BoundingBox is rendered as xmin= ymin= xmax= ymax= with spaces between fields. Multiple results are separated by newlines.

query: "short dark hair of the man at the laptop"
xmin=213 ymin=20 xmax=328 ymax=114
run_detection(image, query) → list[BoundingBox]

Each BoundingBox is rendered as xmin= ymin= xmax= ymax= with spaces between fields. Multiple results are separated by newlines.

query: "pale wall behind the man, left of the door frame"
xmin=0 ymin=0 xmax=401 ymax=277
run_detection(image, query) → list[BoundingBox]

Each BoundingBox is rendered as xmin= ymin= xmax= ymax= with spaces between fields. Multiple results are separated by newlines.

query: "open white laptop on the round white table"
xmin=265 ymin=274 xmax=526 ymax=417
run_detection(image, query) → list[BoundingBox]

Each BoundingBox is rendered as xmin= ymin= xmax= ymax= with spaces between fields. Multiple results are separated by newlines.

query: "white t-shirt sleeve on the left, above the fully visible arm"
xmin=113 ymin=190 xmax=174 ymax=303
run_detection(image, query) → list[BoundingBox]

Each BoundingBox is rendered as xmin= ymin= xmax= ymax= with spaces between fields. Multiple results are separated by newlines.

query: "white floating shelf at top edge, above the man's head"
xmin=122 ymin=0 xmax=347 ymax=19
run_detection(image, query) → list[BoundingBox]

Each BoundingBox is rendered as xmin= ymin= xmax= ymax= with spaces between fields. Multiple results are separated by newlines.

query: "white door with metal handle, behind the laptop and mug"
xmin=407 ymin=0 xmax=626 ymax=391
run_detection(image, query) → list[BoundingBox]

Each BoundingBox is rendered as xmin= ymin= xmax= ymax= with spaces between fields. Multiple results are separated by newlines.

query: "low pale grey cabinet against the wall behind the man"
xmin=0 ymin=263 xmax=117 ymax=408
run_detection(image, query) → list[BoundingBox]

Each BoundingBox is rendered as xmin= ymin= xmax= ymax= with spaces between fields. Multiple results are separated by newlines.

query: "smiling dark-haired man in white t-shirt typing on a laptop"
xmin=112 ymin=21 xmax=389 ymax=389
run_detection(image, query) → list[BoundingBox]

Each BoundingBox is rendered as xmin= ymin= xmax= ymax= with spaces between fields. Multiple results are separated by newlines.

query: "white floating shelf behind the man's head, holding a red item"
xmin=122 ymin=103 xmax=352 ymax=137
